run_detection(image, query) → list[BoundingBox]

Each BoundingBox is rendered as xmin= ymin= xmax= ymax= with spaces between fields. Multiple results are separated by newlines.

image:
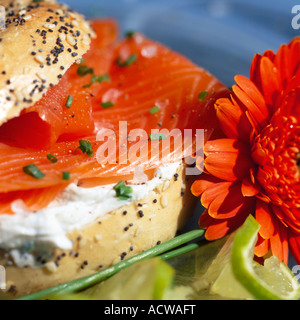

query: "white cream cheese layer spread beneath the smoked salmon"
xmin=0 ymin=163 xmax=180 ymax=267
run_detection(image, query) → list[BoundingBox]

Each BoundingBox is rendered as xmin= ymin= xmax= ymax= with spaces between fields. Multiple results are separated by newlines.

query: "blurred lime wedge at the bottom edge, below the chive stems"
xmin=80 ymin=258 xmax=174 ymax=300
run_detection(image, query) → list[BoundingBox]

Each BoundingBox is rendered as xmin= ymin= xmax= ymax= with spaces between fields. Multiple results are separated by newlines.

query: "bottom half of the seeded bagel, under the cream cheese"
xmin=0 ymin=165 xmax=196 ymax=299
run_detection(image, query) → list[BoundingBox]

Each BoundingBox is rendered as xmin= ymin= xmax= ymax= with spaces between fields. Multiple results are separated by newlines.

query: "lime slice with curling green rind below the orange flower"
xmin=204 ymin=216 xmax=300 ymax=300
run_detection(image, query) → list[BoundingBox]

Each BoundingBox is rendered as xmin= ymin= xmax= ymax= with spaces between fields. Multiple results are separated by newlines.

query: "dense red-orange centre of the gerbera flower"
xmin=252 ymin=116 xmax=300 ymax=208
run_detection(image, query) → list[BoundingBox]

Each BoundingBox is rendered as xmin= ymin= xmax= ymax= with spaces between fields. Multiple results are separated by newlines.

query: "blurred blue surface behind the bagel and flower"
xmin=62 ymin=0 xmax=300 ymax=268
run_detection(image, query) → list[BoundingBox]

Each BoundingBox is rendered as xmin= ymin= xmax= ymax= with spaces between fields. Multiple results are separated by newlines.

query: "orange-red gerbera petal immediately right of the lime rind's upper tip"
xmin=255 ymin=200 xmax=275 ymax=239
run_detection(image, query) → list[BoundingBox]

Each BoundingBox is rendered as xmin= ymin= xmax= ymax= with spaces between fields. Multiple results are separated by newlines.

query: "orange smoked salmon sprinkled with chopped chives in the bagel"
xmin=0 ymin=19 xmax=228 ymax=213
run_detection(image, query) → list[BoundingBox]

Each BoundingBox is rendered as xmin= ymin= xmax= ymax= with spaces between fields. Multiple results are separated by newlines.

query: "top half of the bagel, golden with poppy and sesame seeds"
xmin=0 ymin=0 xmax=94 ymax=125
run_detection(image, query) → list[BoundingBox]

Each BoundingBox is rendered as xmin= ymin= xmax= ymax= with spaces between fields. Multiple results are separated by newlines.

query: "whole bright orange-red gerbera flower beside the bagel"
xmin=192 ymin=37 xmax=300 ymax=264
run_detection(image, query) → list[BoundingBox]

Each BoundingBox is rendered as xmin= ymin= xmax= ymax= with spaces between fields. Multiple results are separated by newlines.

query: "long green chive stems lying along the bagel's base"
xmin=16 ymin=229 xmax=204 ymax=300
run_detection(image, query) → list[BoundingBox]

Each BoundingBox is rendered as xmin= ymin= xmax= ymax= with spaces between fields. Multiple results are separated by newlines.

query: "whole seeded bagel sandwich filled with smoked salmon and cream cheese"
xmin=0 ymin=0 xmax=228 ymax=299
